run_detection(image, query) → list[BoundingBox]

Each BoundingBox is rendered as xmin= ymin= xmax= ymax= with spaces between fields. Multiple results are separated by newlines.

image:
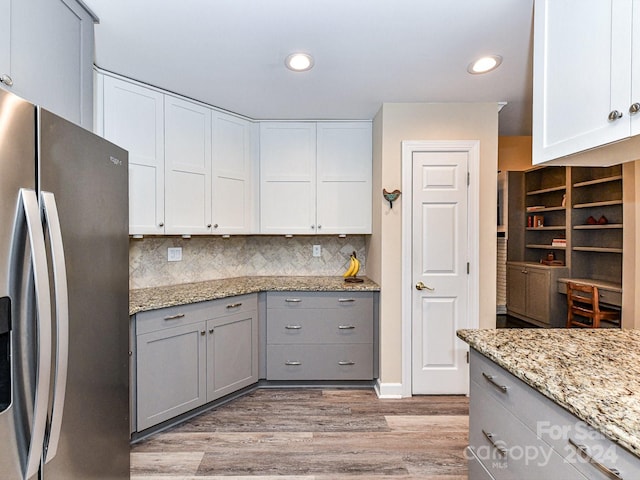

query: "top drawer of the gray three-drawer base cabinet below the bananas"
xmin=267 ymin=292 xmax=373 ymax=311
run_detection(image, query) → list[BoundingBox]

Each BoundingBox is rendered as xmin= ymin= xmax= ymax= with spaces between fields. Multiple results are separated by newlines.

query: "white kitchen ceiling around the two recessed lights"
xmin=84 ymin=0 xmax=533 ymax=135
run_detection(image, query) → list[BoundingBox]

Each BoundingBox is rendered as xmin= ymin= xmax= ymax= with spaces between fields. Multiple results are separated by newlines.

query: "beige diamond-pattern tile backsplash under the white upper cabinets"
xmin=129 ymin=235 xmax=366 ymax=288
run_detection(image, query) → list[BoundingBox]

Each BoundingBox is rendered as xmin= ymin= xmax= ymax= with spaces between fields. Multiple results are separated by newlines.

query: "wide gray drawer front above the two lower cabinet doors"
xmin=136 ymin=294 xmax=258 ymax=335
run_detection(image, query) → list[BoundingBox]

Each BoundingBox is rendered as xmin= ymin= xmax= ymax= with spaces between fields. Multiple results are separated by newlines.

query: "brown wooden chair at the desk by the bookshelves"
xmin=567 ymin=282 xmax=621 ymax=328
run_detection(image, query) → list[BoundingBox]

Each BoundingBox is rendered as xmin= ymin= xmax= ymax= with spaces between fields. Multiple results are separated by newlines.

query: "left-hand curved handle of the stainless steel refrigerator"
xmin=19 ymin=188 xmax=51 ymax=478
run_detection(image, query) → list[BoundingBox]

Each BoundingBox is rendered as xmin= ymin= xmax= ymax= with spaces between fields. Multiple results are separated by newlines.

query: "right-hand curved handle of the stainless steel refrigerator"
xmin=40 ymin=192 xmax=69 ymax=463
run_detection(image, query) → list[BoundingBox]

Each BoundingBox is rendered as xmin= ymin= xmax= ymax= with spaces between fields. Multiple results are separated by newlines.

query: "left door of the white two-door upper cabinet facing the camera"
xmin=260 ymin=122 xmax=316 ymax=235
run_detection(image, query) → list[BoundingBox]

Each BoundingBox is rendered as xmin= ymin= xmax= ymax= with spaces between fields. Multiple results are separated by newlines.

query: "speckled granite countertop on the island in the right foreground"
xmin=458 ymin=329 xmax=640 ymax=456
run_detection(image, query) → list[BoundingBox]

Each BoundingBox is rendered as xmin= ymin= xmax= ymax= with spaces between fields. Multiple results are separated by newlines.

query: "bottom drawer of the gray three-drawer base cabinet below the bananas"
xmin=267 ymin=344 xmax=373 ymax=380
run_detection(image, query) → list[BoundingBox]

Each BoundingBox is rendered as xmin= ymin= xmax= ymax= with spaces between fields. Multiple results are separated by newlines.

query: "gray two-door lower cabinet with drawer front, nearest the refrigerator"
xmin=135 ymin=294 xmax=258 ymax=431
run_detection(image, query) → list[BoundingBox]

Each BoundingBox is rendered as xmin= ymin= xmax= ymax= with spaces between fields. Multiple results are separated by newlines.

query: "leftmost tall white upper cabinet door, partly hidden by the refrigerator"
xmin=103 ymin=75 xmax=164 ymax=235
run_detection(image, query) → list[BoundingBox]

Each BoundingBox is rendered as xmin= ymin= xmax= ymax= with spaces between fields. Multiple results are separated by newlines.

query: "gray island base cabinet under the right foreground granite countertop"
xmin=467 ymin=350 xmax=640 ymax=480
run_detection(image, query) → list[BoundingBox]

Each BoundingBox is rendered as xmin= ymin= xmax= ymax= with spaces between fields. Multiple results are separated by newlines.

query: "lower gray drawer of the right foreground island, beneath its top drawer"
xmin=469 ymin=381 xmax=585 ymax=480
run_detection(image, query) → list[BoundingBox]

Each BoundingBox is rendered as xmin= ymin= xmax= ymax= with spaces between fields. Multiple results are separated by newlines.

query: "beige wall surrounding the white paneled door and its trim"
xmin=367 ymin=103 xmax=498 ymax=384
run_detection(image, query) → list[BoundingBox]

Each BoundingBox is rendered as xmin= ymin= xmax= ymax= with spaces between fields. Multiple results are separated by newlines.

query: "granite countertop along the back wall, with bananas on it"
xmin=129 ymin=276 xmax=380 ymax=315
